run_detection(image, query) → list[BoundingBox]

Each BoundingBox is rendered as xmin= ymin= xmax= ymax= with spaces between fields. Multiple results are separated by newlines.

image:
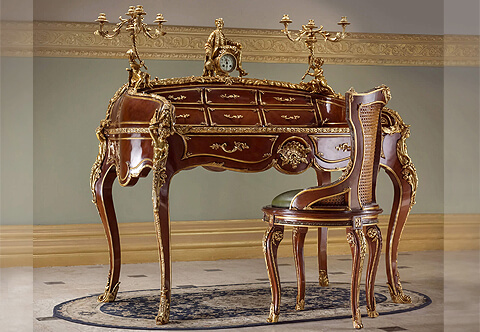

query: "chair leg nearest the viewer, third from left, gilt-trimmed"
xmin=347 ymin=227 xmax=367 ymax=329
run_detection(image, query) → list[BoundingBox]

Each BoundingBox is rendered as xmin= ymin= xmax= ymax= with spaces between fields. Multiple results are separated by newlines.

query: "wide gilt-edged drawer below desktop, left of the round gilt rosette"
xmin=182 ymin=135 xmax=277 ymax=163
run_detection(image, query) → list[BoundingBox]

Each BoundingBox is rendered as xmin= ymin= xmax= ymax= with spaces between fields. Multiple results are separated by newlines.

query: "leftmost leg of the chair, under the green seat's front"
xmin=263 ymin=222 xmax=283 ymax=323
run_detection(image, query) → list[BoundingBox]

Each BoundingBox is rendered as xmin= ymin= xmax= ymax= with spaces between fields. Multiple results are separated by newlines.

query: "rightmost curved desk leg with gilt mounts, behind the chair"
xmin=381 ymin=120 xmax=418 ymax=303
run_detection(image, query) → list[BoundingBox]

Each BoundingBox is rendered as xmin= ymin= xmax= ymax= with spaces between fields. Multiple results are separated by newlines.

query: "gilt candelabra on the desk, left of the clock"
xmin=94 ymin=5 xmax=167 ymax=88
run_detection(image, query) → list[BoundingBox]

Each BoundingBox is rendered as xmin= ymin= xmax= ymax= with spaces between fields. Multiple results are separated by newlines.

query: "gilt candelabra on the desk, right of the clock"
xmin=280 ymin=14 xmax=350 ymax=94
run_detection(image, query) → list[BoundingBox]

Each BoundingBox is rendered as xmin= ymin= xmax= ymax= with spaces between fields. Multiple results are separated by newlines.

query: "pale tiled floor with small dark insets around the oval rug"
xmin=0 ymin=251 xmax=480 ymax=332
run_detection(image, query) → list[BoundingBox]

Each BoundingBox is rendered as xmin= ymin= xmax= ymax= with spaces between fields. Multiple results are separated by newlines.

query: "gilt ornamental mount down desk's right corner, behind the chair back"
xmin=381 ymin=107 xmax=418 ymax=212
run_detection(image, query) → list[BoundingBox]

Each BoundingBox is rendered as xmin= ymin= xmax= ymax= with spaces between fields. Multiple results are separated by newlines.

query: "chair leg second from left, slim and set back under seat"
xmin=292 ymin=227 xmax=308 ymax=310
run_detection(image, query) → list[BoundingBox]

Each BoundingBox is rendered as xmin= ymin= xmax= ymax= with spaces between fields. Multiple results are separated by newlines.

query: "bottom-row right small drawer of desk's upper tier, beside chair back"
xmin=263 ymin=108 xmax=318 ymax=127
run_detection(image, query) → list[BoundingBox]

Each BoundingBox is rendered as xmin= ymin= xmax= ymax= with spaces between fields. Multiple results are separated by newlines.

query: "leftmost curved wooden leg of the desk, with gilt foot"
xmin=95 ymin=165 xmax=121 ymax=302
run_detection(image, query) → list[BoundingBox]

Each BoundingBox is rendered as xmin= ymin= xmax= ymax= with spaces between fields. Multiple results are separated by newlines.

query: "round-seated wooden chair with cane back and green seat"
xmin=262 ymin=86 xmax=390 ymax=329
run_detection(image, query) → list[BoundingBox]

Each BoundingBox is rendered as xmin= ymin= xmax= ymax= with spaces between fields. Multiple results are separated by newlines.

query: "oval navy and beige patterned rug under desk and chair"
xmin=53 ymin=282 xmax=431 ymax=330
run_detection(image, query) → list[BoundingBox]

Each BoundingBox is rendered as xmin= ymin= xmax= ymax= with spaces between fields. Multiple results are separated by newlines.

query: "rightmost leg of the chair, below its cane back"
xmin=365 ymin=225 xmax=382 ymax=318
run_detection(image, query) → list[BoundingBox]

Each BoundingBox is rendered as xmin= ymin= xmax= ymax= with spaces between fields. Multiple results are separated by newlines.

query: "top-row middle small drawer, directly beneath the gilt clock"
xmin=205 ymin=88 xmax=257 ymax=105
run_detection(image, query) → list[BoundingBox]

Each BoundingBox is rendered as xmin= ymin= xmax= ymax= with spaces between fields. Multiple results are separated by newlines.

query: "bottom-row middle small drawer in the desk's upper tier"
xmin=208 ymin=107 xmax=262 ymax=126
